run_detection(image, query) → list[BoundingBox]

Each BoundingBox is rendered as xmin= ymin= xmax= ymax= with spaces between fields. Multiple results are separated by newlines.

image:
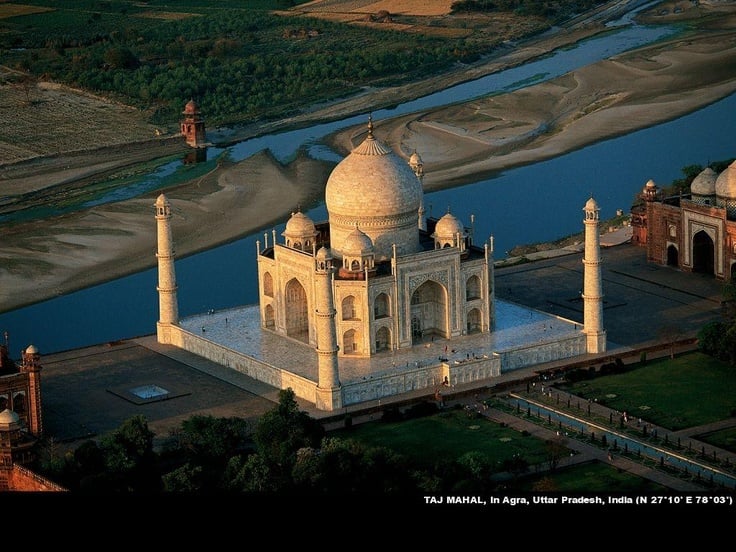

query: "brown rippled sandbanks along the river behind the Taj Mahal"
xmin=0 ymin=2 xmax=736 ymax=312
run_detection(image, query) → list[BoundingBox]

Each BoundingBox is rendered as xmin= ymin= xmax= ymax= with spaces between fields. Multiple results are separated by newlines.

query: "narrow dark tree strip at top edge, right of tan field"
xmin=451 ymin=0 xmax=606 ymax=21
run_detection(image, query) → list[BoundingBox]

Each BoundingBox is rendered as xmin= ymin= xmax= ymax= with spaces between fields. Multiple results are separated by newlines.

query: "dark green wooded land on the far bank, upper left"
xmin=0 ymin=0 xmax=572 ymax=125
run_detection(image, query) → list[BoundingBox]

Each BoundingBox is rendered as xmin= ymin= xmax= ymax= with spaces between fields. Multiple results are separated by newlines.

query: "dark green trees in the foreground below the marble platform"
xmin=34 ymin=389 xmax=528 ymax=496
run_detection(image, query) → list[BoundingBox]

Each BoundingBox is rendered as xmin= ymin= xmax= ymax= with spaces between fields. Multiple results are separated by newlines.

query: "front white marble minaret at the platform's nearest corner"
xmin=314 ymin=247 xmax=342 ymax=411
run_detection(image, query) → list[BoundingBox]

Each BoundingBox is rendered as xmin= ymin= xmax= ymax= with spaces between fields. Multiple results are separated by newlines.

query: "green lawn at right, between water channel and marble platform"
xmin=560 ymin=352 xmax=736 ymax=431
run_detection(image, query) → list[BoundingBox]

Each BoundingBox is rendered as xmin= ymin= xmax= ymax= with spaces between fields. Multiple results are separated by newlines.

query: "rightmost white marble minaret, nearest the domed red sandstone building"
xmin=583 ymin=197 xmax=606 ymax=353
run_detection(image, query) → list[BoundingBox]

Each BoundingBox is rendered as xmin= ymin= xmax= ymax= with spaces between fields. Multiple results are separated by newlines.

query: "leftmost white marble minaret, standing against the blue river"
xmin=155 ymin=194 xmax=179 ymax=343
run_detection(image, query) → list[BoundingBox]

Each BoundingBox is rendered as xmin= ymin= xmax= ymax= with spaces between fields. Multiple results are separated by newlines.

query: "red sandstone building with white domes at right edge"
xmin=631 ymin=161 xmax=736 ymax=281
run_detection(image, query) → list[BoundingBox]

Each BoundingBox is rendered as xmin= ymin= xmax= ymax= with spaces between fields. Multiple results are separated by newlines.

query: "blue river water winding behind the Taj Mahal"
xmin=0 ymin=10 xmax=736 ymax=358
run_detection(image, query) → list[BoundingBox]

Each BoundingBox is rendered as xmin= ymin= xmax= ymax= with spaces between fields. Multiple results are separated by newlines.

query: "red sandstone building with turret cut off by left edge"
xmin=0 ymin=336 xmax=65 ymax=492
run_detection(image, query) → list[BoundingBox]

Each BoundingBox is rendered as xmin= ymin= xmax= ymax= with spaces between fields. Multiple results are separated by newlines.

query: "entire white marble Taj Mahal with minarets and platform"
xmin=155 ymin=118 xmax=606 ymax=411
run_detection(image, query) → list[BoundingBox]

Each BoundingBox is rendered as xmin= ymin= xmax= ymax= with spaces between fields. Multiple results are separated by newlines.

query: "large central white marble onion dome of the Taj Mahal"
xmin=325 ymin=120 xmax=422 ymax=261
